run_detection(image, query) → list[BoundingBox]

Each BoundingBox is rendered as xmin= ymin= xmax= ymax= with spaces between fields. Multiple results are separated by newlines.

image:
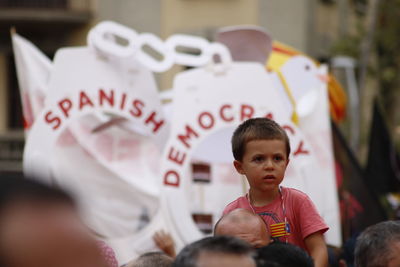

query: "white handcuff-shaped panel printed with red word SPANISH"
xmin=24 ymin=45 xmax=168 ymax=260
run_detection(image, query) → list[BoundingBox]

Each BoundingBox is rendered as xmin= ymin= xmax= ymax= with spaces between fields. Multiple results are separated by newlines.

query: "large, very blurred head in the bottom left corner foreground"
xmin=0 ymin=178 xmax=107 ymax=267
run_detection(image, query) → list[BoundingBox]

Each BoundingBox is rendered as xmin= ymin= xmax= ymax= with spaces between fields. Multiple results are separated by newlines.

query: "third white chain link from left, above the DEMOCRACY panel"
xmin=165 ymin=34 xmax=210 ymax=67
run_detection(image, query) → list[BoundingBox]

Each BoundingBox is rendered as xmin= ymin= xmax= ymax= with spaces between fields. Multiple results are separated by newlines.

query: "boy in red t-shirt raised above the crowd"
xmin=223 ymin=118 xmax=328 ymax=267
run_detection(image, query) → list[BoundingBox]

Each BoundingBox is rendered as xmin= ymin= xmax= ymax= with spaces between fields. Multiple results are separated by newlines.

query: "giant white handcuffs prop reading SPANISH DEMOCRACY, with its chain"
xmin=17 ymin=22 xmax=340 ymax=263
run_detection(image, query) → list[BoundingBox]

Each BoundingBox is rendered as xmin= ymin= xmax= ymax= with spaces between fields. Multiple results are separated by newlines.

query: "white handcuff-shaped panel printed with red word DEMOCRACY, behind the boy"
xmin=161 ymin=62 xmax=324 ymax=247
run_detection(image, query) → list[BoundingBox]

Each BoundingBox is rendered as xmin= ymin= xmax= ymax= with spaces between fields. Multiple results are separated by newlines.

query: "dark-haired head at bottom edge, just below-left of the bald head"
xmin=172 ymin=236 xmax=256 ymax=267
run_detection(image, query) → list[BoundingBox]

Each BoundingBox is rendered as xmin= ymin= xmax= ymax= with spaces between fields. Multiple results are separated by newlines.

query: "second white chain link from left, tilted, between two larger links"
xmin=136 ymin=33 xmax=174 ymax=72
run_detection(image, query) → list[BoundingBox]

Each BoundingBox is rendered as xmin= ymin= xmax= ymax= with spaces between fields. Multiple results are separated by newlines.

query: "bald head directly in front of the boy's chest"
xmin=214 ymin=209 xmax=271 ymax=248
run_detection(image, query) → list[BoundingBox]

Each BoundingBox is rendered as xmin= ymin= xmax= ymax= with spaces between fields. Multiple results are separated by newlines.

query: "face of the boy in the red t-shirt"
xmin=233 ymin=139 xmax=289 ymax=192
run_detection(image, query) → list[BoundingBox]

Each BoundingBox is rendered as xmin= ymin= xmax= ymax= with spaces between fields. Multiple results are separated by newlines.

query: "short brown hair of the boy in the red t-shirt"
xmin=231 ymin=118 xmax=290 ymax=161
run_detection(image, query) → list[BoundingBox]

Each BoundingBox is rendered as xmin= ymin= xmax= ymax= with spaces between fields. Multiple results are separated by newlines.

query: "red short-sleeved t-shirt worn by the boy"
xmin=223 ymin=187 xmax=329 ymax=250
